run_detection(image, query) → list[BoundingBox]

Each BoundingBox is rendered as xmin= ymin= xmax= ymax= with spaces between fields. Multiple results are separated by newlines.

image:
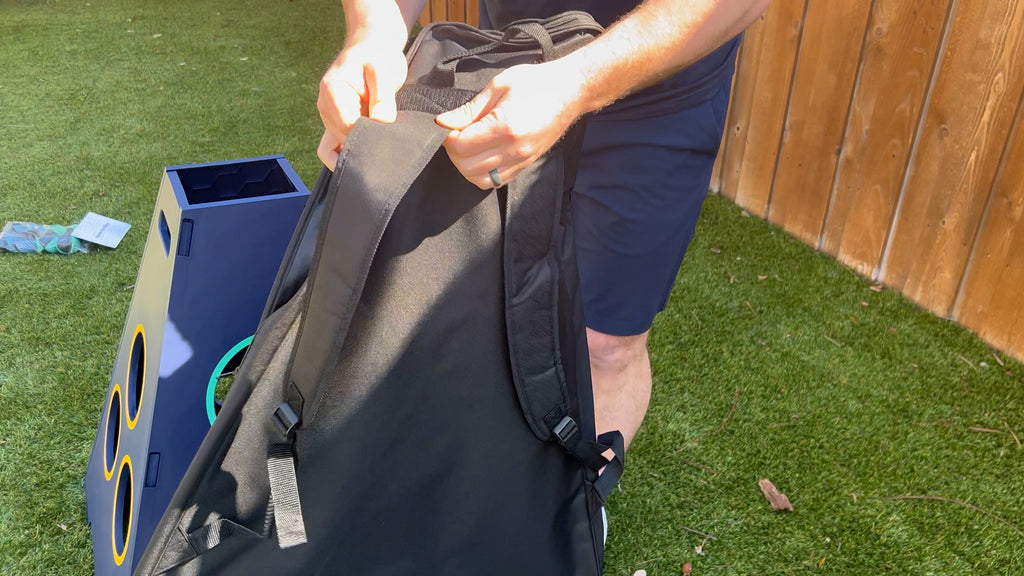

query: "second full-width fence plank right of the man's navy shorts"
xmin=768 ymin=0 xmax=871 ymax=245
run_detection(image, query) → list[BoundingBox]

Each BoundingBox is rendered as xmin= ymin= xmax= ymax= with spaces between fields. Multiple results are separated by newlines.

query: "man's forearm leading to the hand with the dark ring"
xmin=560 ymin=0 xmax=768 ymax=114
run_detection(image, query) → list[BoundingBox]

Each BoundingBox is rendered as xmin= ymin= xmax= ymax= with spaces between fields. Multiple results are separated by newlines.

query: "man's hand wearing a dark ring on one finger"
xmin=437 ymin=60 xmax=583 ymax=190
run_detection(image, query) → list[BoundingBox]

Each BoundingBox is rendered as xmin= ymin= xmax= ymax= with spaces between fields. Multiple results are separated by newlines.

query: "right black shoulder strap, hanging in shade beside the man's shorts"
xmin=504 ymin=132 xmax=625 ymax=483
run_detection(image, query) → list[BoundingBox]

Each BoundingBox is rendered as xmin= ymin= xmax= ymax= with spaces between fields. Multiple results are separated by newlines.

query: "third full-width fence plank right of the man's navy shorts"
xmin=821 ymin=0 xmax=951 ymax=276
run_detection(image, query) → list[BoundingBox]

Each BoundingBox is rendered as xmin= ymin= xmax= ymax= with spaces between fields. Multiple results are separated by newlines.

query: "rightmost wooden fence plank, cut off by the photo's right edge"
xmin=954 ymin=100 xmax=1024 ymax=359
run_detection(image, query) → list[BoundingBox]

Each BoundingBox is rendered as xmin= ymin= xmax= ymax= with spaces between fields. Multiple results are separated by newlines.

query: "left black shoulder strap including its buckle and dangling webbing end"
xmin=260 ymin=111 xmax=447 ymax=548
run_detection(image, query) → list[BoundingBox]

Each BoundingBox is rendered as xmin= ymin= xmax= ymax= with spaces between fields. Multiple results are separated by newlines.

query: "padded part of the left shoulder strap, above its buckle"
xmin=284 ymin=111 xmax=449 ymax=419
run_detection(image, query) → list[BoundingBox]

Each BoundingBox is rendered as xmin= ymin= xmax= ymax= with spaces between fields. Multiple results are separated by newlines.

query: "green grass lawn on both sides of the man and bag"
xmin=0 ymin=0 xmax=1024 ymax=576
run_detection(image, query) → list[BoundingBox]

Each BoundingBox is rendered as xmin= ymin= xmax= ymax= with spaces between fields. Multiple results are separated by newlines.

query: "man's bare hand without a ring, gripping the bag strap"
xmin=316 ymin=41 xmax=407 ymax=170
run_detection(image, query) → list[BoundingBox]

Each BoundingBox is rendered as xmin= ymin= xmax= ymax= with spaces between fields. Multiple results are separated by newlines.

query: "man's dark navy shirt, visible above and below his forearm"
xmin=480 ymin=0 xmax=739 ymax=120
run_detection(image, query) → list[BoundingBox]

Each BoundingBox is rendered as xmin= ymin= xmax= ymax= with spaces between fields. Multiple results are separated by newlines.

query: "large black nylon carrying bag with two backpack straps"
xmin=135 ymin=12 xmax=622 ymax=576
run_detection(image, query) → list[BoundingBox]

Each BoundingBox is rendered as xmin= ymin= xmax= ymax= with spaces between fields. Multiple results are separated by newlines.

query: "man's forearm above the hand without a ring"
xmin=342 ymin=0 xmax=427 ymax=49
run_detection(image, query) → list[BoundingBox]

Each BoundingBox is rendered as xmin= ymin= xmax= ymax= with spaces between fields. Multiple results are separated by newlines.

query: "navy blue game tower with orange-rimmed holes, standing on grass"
xmin=85 ymin=156 xmax=309 ymax=576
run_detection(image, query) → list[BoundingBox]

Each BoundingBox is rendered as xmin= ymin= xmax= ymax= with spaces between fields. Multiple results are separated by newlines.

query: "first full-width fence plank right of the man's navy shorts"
xmin=723 ymin=0 xmax=806 ymax=216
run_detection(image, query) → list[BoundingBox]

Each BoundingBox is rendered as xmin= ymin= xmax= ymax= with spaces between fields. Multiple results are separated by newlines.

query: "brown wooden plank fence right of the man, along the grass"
xmin=713 ymin=0 xmax=1024 ymax=359
